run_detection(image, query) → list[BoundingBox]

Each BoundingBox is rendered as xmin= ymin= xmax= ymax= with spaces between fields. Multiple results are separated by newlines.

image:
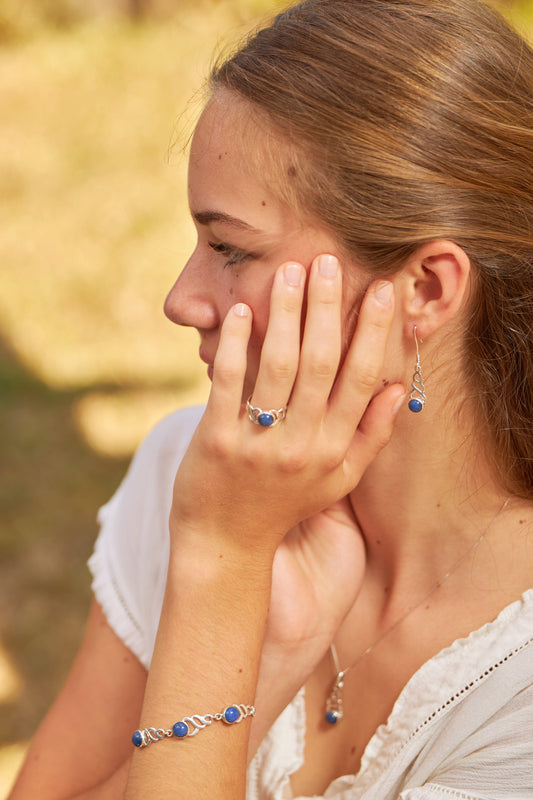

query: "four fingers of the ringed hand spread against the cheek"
xmin=209 ymin=254 xmax=403 ymax=450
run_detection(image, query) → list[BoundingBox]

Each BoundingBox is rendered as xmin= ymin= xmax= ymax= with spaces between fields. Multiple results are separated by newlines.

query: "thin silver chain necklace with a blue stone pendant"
xmin=325 ymin=497 xmax=511 ymax=725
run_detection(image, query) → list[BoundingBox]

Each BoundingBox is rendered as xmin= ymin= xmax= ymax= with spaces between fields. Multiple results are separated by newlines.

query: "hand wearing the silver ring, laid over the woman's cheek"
xmin=171 ymin=256 xmax=403 ymax=563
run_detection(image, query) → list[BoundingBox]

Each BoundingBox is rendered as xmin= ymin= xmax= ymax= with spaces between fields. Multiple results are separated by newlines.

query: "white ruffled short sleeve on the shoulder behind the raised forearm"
xmin=89 ymin=407 xmax=203 ymax=669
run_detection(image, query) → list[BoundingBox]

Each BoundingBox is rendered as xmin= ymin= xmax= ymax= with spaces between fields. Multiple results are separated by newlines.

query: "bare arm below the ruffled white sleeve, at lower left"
xmin=10 ymin=601 xmax=147 ymax=800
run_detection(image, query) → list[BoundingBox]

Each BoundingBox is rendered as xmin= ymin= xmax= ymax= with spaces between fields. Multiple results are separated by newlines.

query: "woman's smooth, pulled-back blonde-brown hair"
xmin=211 ymin=0 xmax=533 ymax=498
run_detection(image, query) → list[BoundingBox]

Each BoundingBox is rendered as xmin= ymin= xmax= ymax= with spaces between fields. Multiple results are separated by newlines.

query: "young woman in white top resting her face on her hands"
xmin=12 ymin=0 xmax=533 ymax=800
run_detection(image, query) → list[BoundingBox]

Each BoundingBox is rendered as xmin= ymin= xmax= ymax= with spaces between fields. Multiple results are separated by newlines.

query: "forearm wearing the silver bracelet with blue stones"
xmin=125 ymin=536 xmax=270 ymax=800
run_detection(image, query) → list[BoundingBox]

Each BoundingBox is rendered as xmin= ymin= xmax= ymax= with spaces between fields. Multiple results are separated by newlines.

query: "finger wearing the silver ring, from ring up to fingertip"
xmin=253 ymin=262 xmax=305 ymax=410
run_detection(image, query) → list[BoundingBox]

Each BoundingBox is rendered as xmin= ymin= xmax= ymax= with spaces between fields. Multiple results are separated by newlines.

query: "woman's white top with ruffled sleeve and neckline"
xmin=89 ymin=408 xmax=533 ymax=800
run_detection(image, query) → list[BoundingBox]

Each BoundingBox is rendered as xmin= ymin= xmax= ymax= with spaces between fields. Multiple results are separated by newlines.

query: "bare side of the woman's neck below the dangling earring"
xmin=351 ymin=398 xmax=532 ymax=595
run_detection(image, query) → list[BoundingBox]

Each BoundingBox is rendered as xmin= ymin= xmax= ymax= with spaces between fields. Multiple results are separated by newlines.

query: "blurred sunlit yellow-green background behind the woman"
xmin=0 ymin=0 xmax=533 ymax=800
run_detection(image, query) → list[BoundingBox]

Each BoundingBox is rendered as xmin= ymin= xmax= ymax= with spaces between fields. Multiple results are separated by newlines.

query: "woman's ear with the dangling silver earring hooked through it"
xmin=397 ymin=239 xmax=471 ymax=338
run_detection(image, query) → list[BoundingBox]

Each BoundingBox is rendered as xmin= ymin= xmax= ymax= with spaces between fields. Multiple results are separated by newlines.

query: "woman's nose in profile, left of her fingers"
xmin=164 ymin=253 xmax=219 ymax=330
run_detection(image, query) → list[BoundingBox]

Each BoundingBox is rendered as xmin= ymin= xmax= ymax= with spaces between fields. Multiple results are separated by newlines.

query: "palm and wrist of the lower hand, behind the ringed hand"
xmin=249 ymin=498 xmax=365 ymax=758
